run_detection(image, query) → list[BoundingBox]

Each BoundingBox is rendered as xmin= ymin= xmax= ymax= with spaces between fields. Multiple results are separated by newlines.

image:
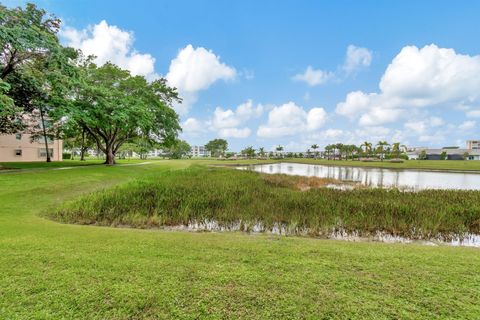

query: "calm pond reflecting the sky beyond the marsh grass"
xmin=239 ymin=162 xmax=480 ymax=190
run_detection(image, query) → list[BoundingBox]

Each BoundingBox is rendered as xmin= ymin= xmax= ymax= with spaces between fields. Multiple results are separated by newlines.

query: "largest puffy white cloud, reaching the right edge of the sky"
xmin=336 ymin=44 xmax=480 ymax=126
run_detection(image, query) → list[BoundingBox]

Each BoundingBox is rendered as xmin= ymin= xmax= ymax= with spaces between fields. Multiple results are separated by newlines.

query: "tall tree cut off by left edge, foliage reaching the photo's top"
xmin=0 ymin=4 xmax=76 ymax=135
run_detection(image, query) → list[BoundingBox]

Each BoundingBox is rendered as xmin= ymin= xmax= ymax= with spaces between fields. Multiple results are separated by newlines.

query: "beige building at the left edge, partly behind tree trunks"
xmin=0 ymin=133 xmax=63 ymax=162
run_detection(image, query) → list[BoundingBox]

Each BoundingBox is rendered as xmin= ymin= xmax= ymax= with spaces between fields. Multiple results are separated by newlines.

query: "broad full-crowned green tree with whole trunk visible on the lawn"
xmin=58 ymin=62 xmax=181 ymax=165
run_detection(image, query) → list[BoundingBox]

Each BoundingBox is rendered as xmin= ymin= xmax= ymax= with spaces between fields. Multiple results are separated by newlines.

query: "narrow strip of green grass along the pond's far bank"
xmin=283 ymin=158 xmax=480 ymax=171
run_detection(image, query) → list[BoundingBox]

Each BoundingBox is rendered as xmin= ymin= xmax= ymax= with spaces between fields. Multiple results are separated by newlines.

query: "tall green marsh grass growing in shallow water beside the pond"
xmin=47 ymin=166 xmax=480 ymax=239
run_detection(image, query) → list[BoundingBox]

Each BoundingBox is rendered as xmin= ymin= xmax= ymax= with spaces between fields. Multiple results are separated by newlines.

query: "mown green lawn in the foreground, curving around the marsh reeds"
xmin=0 ymin=160 xmax=480 ymax=319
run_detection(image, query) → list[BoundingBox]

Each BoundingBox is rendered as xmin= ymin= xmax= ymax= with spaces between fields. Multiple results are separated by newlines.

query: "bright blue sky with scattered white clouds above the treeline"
xmin=3 ymin=0 xmax=480 ymax=151
